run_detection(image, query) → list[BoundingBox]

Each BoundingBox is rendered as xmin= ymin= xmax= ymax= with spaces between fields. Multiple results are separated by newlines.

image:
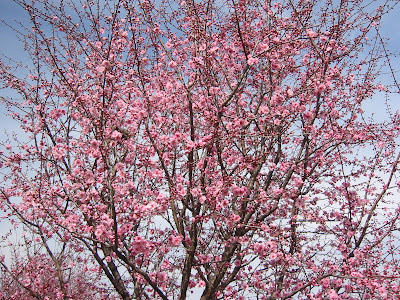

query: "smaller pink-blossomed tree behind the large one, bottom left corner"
xmin=0 ymin=245 xmax=112 ymax=300
